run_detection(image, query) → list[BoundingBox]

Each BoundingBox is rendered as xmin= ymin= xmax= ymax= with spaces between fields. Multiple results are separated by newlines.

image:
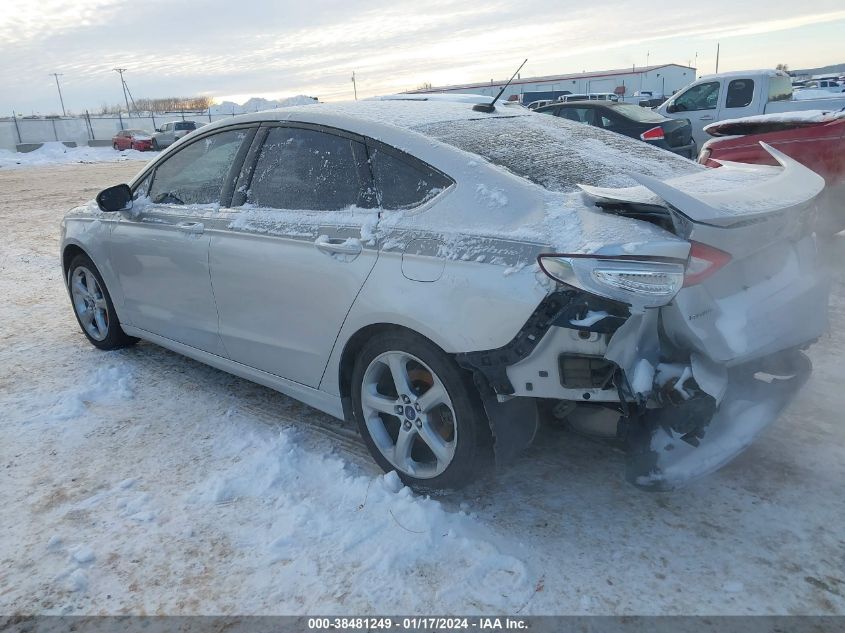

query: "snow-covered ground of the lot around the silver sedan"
xmin=0 ymin=161 xmax=845 ymax=614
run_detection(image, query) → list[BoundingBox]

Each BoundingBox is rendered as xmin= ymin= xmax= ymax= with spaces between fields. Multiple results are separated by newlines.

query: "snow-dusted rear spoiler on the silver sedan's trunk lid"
xmin=578 ymin=141 xmax=825 ymax=227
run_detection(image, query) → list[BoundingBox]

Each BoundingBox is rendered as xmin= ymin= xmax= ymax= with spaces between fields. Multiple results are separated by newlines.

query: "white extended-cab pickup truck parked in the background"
xmin=655 ymin=70 xmax=845 ymax=147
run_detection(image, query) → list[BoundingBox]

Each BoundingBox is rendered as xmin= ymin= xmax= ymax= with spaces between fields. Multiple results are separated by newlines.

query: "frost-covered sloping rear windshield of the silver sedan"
xmin=414 ymin=114 xmax=704 ymax=191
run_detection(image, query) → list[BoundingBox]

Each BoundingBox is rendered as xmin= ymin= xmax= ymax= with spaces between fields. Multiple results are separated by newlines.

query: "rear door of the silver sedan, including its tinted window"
xmin=210 ymin=125 xmax=378 ymax=387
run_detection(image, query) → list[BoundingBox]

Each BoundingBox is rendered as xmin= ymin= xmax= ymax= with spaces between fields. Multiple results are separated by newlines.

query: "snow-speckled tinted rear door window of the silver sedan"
xmin=247 ymin=127 xmax=363 ymax=211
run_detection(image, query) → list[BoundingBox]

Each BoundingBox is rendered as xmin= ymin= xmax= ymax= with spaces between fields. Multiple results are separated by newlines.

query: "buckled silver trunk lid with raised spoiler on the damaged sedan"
xmin=582 ymin=144 xmax=828 ymax=366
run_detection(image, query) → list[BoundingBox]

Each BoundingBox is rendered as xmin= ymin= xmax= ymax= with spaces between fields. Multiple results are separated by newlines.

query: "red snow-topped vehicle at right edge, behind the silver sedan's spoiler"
xmin=698 ymin=111 xmax=845 ymax=232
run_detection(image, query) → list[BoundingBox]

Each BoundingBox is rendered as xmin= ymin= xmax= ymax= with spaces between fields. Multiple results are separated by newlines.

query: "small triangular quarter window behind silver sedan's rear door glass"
xmin=369 ymin=147 xmax=452 ymax=209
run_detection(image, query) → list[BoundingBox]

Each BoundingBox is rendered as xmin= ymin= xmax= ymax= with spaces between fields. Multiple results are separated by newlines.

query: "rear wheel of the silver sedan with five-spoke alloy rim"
xmin=351 ymin=330 xmax=491 ymax=491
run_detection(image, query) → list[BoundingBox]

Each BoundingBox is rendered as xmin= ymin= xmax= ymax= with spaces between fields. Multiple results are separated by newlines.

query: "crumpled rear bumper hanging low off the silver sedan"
xmin=625 ymin=350 xmax=812 ymax=491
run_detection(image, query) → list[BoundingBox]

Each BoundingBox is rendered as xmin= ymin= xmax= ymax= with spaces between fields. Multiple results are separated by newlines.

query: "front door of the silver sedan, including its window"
xmin=110 ymin=127 xmax=255 ymax=356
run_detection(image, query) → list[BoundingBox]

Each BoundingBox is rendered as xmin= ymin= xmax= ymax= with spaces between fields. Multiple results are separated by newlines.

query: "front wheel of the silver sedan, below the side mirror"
xmin=66 ymin=253 xmax=138 ymax=350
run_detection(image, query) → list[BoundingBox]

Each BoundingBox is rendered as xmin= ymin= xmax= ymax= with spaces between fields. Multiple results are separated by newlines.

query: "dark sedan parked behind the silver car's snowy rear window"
xmin=537 ymin=101 xmax=698 ymax=158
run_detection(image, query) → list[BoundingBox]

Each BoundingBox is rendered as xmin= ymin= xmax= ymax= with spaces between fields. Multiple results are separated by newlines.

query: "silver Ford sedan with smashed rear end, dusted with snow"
xmin=61 ymin=97 xmax=828 ymax=489
